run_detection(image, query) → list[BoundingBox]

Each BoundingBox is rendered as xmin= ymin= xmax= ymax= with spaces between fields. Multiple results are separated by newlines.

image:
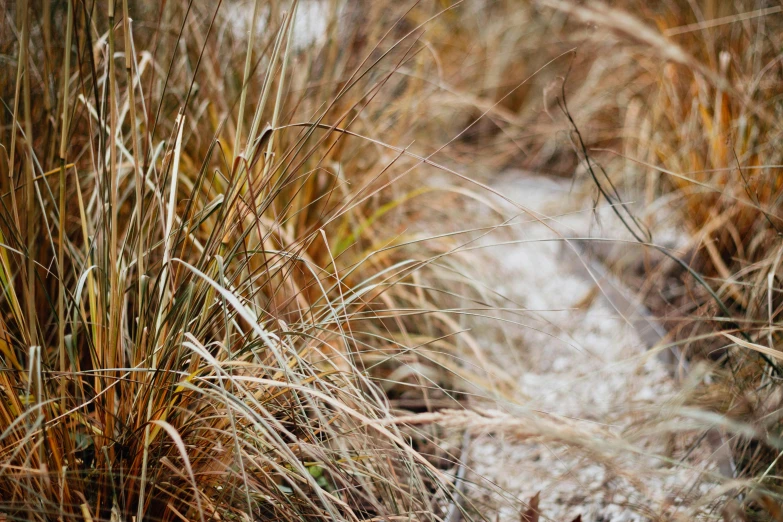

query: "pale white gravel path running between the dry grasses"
xmin=460 ymin=173 xmax=716 ymax=522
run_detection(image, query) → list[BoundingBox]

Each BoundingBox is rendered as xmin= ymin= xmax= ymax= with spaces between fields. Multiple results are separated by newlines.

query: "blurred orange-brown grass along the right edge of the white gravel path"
xmin=500 ymin=0 xmax=783 ymax=519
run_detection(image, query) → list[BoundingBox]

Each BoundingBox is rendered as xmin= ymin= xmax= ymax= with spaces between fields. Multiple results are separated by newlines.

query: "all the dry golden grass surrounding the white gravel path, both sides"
xmin=6 ymin=0 xmax=783 ymax=520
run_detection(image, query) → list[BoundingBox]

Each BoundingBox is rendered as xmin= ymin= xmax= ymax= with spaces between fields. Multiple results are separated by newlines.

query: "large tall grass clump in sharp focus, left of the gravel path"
xmin=0 ymin=0 xmax=490 ymax=520
